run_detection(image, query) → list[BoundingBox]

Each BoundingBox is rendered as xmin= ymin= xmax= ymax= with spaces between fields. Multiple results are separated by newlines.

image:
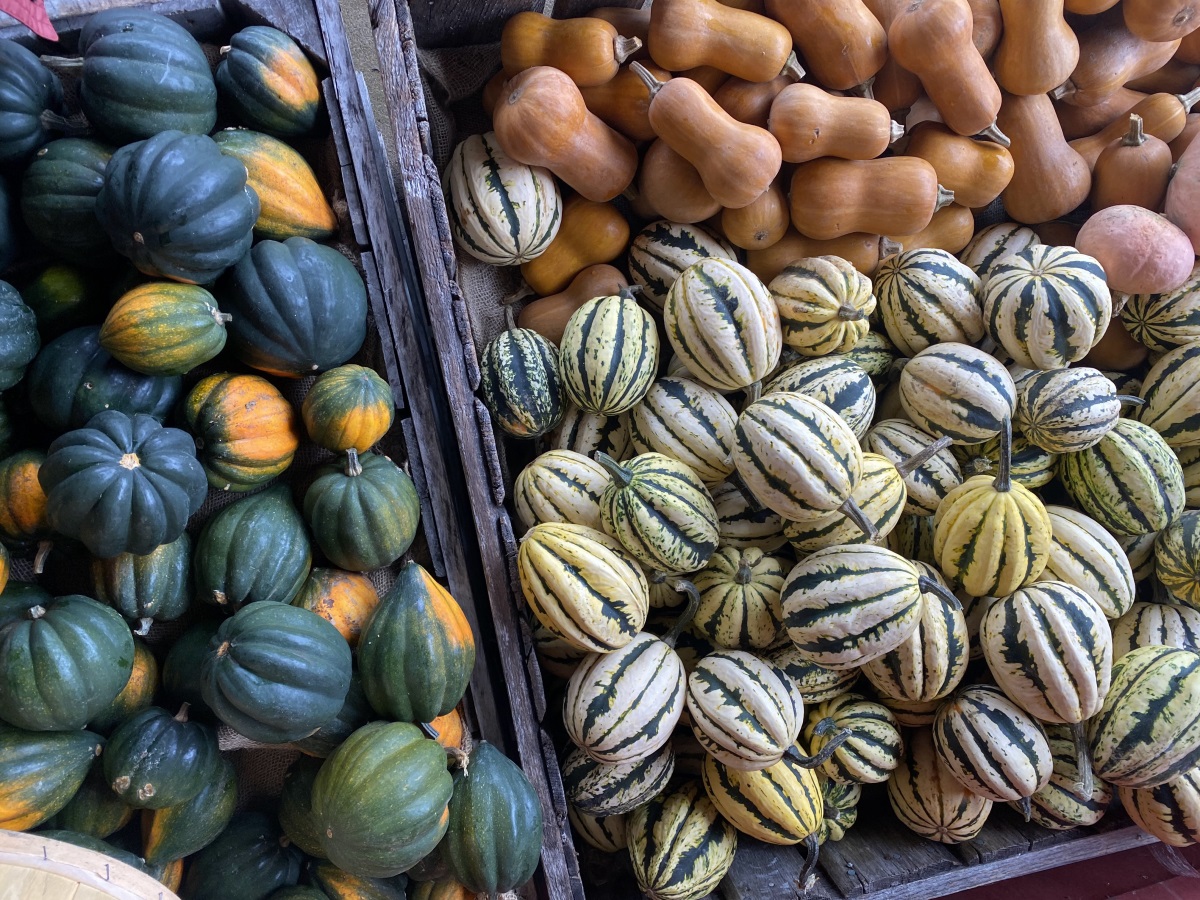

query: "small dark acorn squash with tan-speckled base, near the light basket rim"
xmin=104 ymin=703 xmax=221 ymax=809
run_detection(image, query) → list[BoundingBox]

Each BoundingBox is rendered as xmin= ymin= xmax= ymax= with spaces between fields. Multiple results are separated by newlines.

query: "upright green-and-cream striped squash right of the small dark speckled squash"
xmin=558 ymin=290 xmax=659 ymax=415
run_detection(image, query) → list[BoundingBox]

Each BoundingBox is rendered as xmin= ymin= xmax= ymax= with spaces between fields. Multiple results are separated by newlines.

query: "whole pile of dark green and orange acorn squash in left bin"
xmin=0 ymin=8 xmax=542 ymax=900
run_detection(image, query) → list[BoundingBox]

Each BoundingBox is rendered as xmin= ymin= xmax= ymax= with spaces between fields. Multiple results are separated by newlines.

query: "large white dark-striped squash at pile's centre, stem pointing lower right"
xmin=733 ymin=392 xmax=863 ymax=520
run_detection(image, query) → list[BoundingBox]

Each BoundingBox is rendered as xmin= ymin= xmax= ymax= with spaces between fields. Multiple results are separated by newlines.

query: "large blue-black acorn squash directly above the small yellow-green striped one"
xmin=96 ymin=131 xmax=260 ymax=284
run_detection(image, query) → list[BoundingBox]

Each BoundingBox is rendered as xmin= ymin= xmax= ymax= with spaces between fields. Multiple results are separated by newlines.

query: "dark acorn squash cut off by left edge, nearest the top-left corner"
xmin=0 ymin=40 xmax=62 ymax=166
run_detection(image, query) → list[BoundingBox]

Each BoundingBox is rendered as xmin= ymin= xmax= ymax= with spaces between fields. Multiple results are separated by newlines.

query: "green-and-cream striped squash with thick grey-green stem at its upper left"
xmin=598 ymin=454 xmax=718 ymax=574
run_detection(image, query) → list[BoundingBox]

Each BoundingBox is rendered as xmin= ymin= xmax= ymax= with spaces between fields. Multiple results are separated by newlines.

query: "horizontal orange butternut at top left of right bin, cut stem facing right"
xmin=500 ymin=11 xmax=642 ymax=88
